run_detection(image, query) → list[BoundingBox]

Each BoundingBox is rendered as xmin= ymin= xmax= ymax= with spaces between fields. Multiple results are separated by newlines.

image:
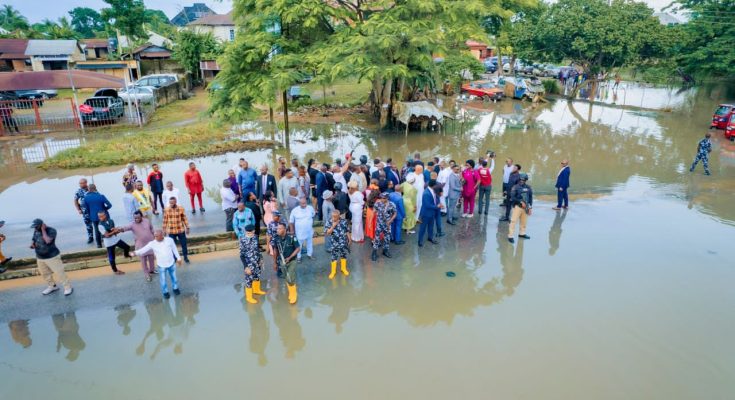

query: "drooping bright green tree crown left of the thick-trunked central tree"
xmin=211 ymin=0 xmax=336 ymax=125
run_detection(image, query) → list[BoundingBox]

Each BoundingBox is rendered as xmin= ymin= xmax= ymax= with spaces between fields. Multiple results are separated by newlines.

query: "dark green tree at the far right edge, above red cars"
xmin=673 ymin=0 xmax=735 ymax=78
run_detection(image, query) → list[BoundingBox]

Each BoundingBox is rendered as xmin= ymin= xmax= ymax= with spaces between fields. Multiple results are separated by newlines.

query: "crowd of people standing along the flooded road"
xmin=10 ymin=151 xmax=570 ymax=304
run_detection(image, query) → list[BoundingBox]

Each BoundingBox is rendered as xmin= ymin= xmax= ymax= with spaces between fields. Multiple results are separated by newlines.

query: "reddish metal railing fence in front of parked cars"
xmin=0 ymin=97 xmax=155 ymax=136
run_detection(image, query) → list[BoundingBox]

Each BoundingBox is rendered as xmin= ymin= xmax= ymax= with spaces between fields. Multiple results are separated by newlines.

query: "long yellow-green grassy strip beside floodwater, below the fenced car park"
xmin=40 ymin=122 xmax=275 ymax=169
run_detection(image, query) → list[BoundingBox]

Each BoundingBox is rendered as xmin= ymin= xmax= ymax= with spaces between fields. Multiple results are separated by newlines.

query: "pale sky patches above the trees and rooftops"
xmin=2 ymin=0 xmax=671 ymax=23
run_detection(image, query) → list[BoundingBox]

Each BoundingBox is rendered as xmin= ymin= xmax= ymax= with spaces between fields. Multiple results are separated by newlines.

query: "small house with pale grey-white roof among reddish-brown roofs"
xmin=26 ymin=39 xmax=85 ymax=71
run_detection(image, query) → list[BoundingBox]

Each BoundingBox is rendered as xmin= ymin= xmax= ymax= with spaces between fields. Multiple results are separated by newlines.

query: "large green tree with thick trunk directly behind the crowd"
xmin=315 ymin=0 xmax=512 ymax=128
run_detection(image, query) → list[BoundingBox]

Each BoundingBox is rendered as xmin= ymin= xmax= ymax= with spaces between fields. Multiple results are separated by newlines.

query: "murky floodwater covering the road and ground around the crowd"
xmin=0 ymin=82 xmax=735 ymax=399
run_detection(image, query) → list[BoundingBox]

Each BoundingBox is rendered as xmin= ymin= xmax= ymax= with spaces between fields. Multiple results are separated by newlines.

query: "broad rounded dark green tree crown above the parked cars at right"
xmin=516 ymin=0 xmax=672 ymax=73
